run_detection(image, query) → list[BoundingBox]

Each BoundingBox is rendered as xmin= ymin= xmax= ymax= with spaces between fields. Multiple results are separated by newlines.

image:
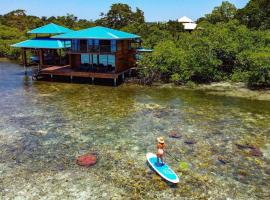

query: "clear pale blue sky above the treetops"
xmin=0 ymin=0 xmax=248 ymax=22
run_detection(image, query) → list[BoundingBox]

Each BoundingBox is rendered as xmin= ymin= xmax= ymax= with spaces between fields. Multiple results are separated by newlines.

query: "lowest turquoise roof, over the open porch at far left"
xmin=11 ymin=38 xmax=71 ymax=49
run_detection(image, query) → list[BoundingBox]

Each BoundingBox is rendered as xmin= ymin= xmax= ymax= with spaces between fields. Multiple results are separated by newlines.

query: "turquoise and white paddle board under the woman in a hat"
xmin=146 ymin=153 xmax=179 ymax=183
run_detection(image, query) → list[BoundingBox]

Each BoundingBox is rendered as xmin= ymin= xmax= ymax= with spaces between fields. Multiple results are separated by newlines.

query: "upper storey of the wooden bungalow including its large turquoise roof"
xmin=54 ymin=26 xmax=141 ymax=54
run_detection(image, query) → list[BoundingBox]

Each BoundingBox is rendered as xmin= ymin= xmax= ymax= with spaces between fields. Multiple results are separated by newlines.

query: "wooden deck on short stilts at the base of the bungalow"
xmin=38 ymin=65 xmax=130 ymax=85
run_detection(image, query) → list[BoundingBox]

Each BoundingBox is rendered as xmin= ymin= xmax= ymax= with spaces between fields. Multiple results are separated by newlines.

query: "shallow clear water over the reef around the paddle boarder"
xmin=0 ymin=62 xmax=270 ymax=199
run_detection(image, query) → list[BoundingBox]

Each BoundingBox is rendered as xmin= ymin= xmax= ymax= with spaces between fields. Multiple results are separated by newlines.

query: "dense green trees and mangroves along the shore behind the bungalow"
xmin=0 ymin=0 xmax=270 ymax=88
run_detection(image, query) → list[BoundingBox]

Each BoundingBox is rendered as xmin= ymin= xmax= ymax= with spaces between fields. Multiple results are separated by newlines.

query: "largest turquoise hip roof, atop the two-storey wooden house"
xmin=53 ymin=26 xmax=140 ymax=40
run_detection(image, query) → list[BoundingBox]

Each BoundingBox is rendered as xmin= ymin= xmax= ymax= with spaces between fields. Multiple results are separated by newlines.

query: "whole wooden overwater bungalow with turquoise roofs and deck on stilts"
xmin=12 ymin=24 xmax=148 ymax=85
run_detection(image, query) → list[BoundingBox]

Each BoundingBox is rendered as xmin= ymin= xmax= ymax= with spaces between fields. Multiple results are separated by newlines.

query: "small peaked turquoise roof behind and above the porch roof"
xmin=27 ymin=23 xmax=73 ymax=34
